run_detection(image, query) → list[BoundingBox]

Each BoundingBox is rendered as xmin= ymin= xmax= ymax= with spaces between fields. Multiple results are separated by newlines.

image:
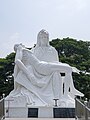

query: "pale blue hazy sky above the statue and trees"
xmin=0 ymin=0 xmax=90 ymax=58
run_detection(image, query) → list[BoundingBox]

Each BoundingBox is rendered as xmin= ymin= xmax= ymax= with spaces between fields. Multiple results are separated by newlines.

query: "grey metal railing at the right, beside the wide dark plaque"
xmin=75 ymin=98 xmax=90 ymax=120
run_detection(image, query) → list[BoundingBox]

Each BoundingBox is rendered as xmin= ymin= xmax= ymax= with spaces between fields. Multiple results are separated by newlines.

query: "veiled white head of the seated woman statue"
xmin=37 ymin=29 xmax=49 ymax=46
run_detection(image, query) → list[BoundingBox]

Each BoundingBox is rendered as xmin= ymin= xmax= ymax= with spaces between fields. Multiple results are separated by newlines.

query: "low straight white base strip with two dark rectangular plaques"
xmin=5 ymin=106 xmax=75 ymax=118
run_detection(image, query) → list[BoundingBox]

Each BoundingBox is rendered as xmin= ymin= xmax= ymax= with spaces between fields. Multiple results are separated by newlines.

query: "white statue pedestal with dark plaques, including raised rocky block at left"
xmin=5 ymin=96 xmax=75 ymax=118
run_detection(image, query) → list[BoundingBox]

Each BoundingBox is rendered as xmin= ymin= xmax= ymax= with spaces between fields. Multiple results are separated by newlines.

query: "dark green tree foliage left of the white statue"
xmin=0 ymin=53 xmax=15 ymax=96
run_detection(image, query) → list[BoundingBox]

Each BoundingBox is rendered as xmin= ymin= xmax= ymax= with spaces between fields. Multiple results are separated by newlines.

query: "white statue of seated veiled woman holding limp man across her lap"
xmin=6 ymin=30 xmax=83 ymax=107
